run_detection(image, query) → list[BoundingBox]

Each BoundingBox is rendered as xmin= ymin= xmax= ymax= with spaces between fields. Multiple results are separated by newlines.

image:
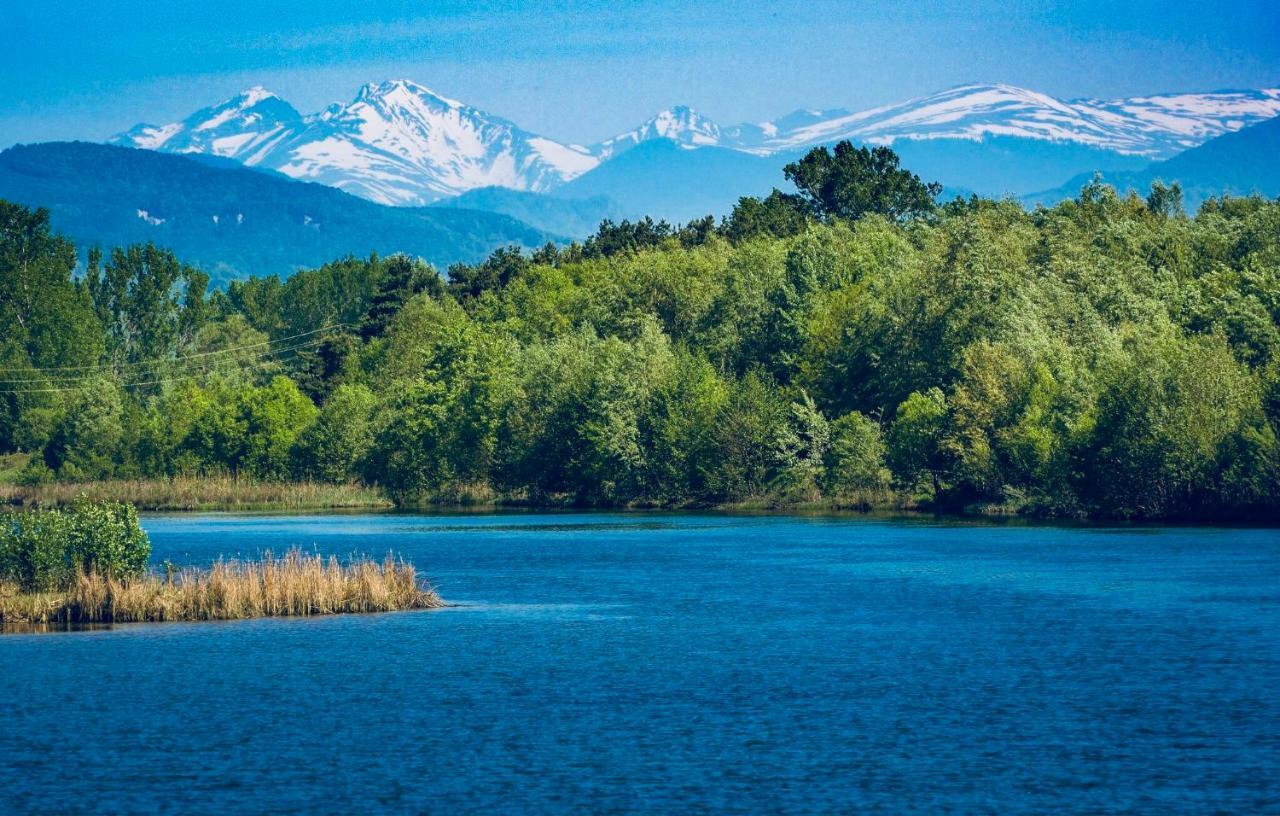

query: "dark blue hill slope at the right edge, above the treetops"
xmin=1025 ymin=119 xmax=1280 ymax=210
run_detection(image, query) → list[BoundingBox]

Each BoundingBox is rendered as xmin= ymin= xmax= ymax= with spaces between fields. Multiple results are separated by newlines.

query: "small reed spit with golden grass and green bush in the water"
xmin=0 ymin=500 xmax=444 ymax=627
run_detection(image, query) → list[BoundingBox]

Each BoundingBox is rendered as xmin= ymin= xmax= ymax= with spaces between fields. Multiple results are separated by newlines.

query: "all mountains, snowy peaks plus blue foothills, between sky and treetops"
xmin=0 ymin=81 xmax=1280 ymax=283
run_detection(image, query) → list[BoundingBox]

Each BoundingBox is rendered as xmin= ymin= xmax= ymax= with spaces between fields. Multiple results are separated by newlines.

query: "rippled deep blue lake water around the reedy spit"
xmin=0 ymin=514 xmax=1280 ymax=813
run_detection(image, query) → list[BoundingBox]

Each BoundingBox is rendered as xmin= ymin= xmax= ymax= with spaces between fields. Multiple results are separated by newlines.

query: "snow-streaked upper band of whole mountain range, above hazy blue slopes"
xmin=113 ymin=79 xmax=1280 ymax=205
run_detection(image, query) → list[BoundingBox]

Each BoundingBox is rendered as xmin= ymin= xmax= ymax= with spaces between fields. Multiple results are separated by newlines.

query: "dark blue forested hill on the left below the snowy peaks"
xmin=0 ymin=142 xmax=559 ymax=283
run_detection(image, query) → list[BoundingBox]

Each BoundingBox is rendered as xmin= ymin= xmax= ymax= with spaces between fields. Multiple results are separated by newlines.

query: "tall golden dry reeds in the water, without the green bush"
xmin=0 ymin=550 xmax=444 ymax=624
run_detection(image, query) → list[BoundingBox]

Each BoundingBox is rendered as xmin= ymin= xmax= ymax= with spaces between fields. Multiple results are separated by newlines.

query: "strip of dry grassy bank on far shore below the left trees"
xmin=0 ymin=476 xmax=390 ymax=510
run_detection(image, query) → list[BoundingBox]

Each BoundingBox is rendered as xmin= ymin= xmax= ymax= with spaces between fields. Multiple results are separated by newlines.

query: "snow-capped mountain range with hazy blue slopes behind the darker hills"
xmin=113 ymin=79 xmax=1280 ymax=220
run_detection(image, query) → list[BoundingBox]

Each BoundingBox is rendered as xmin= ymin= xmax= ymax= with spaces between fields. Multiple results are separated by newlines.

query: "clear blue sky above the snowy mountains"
xmin=0 ymin=0 xmax=1280 ymax=147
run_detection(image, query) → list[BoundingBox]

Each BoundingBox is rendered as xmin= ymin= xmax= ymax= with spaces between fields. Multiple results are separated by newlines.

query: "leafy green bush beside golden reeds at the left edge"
xmin=0 ymin=499 xmax=151 ymax=591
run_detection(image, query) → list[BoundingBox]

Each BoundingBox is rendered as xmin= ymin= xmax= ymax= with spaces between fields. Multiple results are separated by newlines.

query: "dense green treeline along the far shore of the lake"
xmin=0 ymin=145 xmax=1280 ymax=519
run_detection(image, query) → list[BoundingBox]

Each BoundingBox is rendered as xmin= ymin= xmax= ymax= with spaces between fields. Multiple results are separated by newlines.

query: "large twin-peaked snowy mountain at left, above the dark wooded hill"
xmin=113 ymin=79 xmax=599 ymax=205
